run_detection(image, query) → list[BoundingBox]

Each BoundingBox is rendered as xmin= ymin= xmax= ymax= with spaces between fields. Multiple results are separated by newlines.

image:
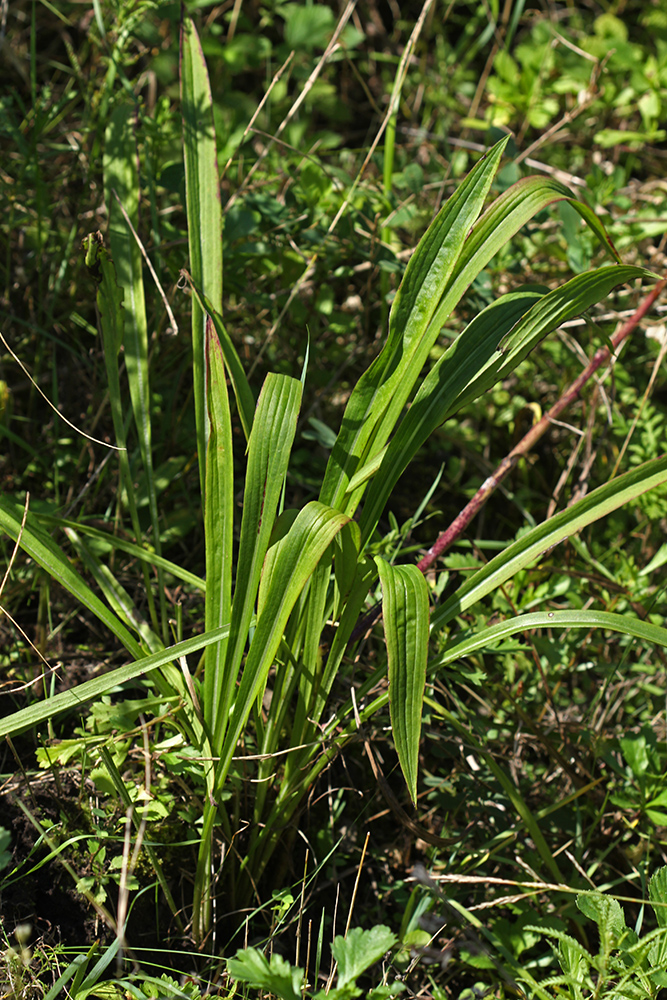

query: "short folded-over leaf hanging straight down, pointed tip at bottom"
xmin=375 ymin=556 xmax=429 ymax=802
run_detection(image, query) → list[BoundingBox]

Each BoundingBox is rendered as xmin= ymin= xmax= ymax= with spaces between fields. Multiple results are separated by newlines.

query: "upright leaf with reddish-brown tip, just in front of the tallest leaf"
xmin=203 ymin=319 xmax=236 ymax=733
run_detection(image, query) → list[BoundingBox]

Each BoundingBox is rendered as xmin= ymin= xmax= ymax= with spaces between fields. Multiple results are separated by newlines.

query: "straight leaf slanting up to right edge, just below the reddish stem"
xmin=431 ymin=458 xmax=667 ymax=631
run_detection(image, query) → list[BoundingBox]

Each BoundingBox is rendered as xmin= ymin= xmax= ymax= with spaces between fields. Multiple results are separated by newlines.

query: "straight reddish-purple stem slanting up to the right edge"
xmin=417 ymin=278 xmax=667 ymax=573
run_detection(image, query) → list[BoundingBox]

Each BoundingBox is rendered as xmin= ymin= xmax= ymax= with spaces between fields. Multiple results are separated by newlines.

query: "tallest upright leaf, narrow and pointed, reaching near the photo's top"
xmin=180 ymin=17 xmax=222 ymax=497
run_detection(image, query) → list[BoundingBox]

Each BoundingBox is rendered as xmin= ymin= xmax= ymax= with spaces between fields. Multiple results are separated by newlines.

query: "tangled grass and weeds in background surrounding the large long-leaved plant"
xmin=0 ymin=0 xmax=667 ymax=998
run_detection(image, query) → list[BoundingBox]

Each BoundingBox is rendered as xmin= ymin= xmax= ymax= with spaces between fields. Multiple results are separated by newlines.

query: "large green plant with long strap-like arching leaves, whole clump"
xmin=0 ymin=11 xmax=667 ymax=942
